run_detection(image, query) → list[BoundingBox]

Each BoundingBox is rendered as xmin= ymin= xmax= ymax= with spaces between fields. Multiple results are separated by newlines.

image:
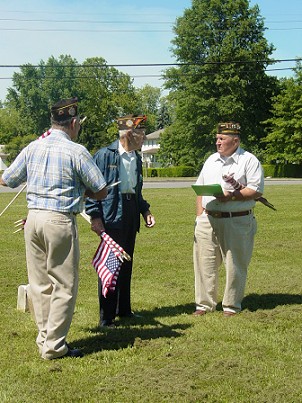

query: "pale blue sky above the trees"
xmin=0 ymin=0 xmax=302 ymax=101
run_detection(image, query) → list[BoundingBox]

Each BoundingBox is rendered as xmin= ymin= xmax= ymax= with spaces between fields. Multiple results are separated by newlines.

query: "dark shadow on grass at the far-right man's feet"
xmin=242 ymin=294 xmax=302 ymax=312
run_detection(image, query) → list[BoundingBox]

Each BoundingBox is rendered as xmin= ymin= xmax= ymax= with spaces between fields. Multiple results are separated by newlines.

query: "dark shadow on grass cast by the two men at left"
xmin=74 ymin=304 xmax=192 ymax=355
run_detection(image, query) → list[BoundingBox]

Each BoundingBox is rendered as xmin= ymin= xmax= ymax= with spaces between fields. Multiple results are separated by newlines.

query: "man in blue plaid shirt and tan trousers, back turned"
xmin=0 ymin=98 xmax=107 ymax=360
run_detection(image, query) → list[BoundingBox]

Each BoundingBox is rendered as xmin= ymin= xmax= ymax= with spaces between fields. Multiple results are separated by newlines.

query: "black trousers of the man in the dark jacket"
xmin=98 ymin=195 xmax=139 ymax=322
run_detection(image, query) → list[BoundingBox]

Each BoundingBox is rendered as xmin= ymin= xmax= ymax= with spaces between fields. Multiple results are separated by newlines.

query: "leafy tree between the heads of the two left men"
xmin=79 ymin=58 xmax=136 ymax=153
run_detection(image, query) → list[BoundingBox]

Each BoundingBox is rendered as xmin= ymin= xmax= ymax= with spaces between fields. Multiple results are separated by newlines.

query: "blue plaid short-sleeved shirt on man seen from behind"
xmin=2 ymin=130 xmax=106 ymax=213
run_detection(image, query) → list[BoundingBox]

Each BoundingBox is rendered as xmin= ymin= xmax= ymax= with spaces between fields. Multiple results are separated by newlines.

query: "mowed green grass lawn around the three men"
xmin=0 ymin=185 xmax=302 ymax=402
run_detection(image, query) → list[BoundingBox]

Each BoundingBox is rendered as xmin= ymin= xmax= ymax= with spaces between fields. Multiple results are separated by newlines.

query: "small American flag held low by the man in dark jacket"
xmin=92 ymin=232 xmax=131 ymax=298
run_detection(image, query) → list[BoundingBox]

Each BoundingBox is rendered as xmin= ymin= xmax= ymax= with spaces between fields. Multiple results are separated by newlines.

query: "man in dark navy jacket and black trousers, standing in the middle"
xmin=86 ymin=115 xmax=155 ymax=327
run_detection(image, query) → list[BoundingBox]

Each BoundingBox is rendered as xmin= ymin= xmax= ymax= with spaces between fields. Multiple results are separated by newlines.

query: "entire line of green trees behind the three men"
xmin=0 ymin=0 xmax=302 ymax=167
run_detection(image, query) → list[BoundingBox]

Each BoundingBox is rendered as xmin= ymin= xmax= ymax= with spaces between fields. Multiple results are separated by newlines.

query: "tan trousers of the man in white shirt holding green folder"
xmin=193 ymin=213 xmax=257 ymax=312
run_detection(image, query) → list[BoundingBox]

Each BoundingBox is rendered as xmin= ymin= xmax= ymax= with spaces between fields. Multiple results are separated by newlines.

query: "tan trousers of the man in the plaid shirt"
xmin=24 ymin=210 xmax=80 ymax=359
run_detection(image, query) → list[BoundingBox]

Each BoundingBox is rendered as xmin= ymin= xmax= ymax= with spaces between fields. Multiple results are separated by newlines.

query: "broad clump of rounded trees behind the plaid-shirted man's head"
xmin=0 ymin=55 xmax=137 ymax=152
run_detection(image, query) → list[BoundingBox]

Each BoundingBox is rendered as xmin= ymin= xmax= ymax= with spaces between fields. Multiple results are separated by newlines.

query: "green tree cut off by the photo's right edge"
xmin=265 ymin=62 xmax=302 ymax=164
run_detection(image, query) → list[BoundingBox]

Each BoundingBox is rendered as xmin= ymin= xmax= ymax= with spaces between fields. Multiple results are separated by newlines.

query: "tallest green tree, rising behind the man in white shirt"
xmin=160 ymin=0 xmax=277 ymax=165
